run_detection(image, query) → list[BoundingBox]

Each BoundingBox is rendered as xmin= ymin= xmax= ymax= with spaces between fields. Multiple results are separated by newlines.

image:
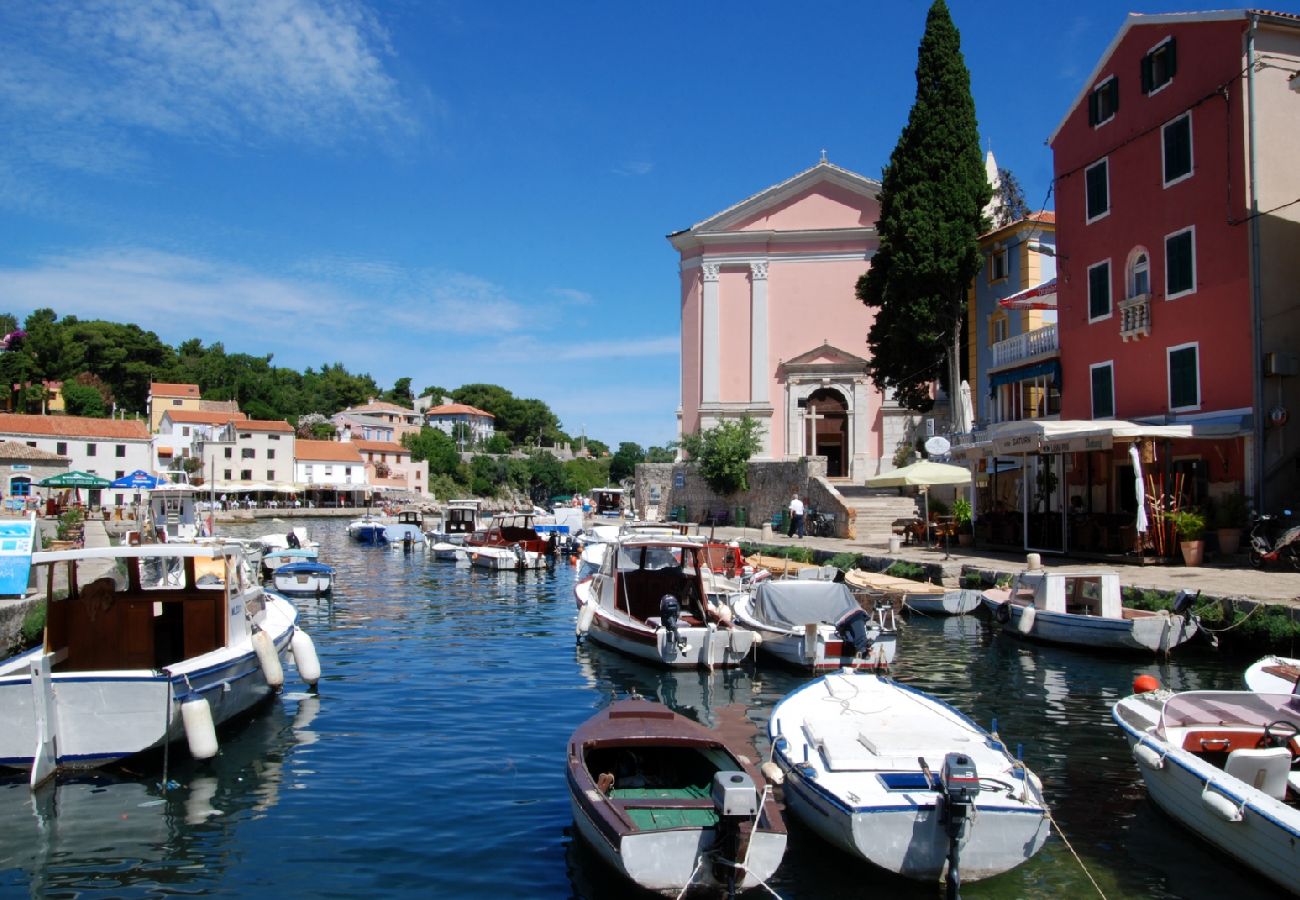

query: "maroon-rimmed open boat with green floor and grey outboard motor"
xmin=568 ymin=700 xmax=785 ymax=896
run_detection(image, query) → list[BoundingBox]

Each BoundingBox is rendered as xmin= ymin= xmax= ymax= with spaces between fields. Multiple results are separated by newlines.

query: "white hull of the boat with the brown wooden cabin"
xmin=0 ymin=597 xmax=296 ymax=770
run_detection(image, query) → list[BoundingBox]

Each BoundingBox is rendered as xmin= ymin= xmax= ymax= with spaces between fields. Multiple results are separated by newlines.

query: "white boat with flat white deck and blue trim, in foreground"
xmin=768 ymin=670 xmax=1048 ymax=884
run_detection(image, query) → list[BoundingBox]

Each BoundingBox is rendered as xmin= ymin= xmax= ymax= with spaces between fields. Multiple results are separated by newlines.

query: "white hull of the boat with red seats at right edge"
xmin=1112 ymin=697 xmax=1300 ymax=892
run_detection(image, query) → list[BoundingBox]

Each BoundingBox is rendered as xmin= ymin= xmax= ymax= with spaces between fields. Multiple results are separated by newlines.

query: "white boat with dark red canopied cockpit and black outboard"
xmin=573 ymin=537 xmax=754 ymax=668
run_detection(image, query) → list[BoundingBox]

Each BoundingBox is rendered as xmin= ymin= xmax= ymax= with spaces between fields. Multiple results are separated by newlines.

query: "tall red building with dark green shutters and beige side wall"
xmin=1049 ymin=10 xmax=1300 ymax=520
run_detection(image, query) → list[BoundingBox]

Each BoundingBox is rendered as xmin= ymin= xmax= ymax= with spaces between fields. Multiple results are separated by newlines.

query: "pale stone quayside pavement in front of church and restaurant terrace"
xmin=699 ymin=525 xmax=1300 ymax=609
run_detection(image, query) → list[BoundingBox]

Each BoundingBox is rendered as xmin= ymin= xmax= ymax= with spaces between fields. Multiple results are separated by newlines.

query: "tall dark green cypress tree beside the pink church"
xmin=857 ymin=0 xmax=992 ymax=415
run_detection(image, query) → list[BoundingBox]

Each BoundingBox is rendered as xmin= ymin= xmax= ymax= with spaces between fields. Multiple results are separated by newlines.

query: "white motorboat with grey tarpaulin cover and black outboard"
xmin=728 ymin=579 xmax=898 ymax=671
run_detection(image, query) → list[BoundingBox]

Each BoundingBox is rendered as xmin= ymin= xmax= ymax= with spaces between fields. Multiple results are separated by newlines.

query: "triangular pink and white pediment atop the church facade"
xmin=670 ymin=156 xmax=880 ymax=248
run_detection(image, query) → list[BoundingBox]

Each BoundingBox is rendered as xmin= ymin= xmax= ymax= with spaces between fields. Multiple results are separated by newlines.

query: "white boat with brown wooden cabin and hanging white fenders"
xmin=0 ymin=544 xmax=320 ymax=786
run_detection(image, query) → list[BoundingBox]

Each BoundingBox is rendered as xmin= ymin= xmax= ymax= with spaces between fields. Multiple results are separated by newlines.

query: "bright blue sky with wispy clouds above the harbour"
xmin=0 ymin=0 xmax=1296 ymax=445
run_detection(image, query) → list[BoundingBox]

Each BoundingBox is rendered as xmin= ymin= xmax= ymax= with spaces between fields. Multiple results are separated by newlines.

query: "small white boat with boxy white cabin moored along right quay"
xmin=983 ymin=570 xmax=1196 ymax=653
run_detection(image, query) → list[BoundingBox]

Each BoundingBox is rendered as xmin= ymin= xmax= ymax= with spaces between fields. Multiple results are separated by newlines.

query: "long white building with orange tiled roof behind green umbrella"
xmin=0 ymin=412 xmax=153 ymax=506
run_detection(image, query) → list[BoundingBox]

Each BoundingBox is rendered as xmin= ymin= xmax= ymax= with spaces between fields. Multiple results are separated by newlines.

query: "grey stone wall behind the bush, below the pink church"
xmin=633 ymin=457 xmax=850 ymax=537
